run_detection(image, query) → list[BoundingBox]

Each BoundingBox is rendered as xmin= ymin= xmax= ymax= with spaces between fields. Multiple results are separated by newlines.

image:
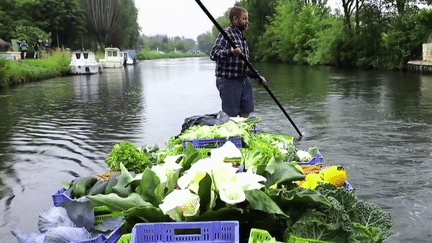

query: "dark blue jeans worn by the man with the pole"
xmin=216 ymin=77 xmax=254 ymax=117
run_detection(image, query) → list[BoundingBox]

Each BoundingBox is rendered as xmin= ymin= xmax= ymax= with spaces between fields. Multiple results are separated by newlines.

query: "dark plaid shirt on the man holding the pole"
xmin=210 ymin=26 xmax=253 ymax=79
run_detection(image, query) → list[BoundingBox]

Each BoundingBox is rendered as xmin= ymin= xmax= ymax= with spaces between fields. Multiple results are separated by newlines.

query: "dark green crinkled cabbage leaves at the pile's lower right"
xmin=286 ymin=184 xmax=392 ymax=243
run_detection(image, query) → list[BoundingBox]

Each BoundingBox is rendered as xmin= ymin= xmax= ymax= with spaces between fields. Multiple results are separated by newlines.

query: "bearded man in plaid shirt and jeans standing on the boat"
xmin=210 ymin=6 xmax=266 ymax=118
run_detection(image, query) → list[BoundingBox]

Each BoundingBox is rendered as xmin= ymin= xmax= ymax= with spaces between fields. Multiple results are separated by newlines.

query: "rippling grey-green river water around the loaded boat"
xmin=0 ymin=58 xmax=432 ymax=242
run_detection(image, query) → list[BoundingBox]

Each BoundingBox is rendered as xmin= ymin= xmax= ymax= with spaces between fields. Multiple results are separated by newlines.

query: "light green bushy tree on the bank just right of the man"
xmin=257 ymin=0 xmax=343 ymax=64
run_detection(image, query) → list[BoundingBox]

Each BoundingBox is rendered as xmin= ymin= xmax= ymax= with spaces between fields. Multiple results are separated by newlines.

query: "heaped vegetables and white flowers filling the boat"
xmin=13 ymin=115 xmax=392 ymax=243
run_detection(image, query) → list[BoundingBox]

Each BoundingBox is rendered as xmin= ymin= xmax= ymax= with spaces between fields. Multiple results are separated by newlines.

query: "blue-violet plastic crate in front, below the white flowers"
xmin=131 ymin=221 xmax=239 ymax=243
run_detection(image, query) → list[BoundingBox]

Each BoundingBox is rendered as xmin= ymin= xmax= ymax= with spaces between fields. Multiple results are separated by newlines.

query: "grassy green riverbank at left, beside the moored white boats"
xmin=0 ymin=50 xmax=71 ymax=88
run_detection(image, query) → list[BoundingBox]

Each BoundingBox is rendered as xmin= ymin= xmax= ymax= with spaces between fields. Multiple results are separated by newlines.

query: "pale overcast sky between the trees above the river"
xmin=135 ymin=0 xmax=236 ymax=40
